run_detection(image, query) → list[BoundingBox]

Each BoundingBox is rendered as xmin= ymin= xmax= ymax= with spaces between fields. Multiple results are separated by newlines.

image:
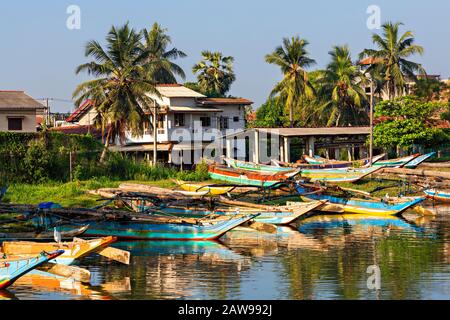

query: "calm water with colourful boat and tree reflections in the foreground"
xmin=0 ymin=204 xmax=450 ymax=299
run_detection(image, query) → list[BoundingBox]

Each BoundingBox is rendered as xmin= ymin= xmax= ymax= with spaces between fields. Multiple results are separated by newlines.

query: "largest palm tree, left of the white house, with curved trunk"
xmin=73 ymin=23 xmax=159 ymax=161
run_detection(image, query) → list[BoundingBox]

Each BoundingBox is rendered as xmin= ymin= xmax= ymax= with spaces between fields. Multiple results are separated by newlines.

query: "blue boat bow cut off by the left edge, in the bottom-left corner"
xmin=0 ymin=250 xmax=64 ymax=290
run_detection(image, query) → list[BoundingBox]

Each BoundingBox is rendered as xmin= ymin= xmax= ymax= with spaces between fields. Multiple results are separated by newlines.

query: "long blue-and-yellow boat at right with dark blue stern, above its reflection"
xmin=296 ymin=184 xmax=425 ymax=216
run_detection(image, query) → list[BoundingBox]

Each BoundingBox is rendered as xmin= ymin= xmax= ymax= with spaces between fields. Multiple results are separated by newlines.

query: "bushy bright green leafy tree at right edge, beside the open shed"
xmin=374 ymin=96 xmax=450 ymax=151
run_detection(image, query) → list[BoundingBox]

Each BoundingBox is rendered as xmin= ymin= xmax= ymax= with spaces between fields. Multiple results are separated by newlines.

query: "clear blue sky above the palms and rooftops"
xmin=0 ymin=0 xmax=450 ymax=111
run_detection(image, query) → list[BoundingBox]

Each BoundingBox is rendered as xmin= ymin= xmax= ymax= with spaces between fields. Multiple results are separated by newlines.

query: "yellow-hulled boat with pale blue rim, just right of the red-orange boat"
xmin=300 ymin=167 xmax=380 ymax=183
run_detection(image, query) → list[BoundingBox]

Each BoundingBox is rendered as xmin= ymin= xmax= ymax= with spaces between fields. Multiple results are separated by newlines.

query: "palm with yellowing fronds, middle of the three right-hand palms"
xmin=320 ymin=46 xmax=367 ymax=126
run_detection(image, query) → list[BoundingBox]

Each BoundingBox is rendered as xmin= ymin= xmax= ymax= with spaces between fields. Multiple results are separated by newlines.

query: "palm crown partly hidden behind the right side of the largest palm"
xmin=142 ymin=22 xmax=186 ymax=83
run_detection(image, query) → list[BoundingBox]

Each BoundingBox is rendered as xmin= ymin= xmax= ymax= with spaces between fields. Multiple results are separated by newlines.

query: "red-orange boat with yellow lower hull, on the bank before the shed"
xmin=208 ymin=165 xmax=299 ymax=187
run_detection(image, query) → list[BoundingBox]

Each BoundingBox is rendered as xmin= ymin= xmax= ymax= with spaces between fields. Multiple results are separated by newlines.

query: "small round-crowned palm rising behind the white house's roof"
xmin=192 ymin=50 xmax=236 ymax=96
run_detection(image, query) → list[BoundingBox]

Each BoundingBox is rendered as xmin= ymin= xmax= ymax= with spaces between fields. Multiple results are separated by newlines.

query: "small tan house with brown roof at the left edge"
xmin=0 ymin=91 xmax=44 ymax=132
